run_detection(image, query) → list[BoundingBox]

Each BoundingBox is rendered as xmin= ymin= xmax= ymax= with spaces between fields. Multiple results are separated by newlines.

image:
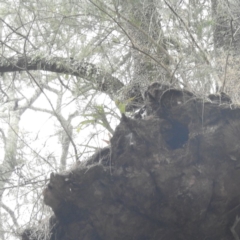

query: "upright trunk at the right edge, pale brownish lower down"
xmin=211 ymin=0 xmax=240 ymax=97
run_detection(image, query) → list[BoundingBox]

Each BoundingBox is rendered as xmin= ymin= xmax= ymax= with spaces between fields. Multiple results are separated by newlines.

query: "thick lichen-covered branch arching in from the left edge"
xmin=0 ymin=55 xmax=124 ymax=98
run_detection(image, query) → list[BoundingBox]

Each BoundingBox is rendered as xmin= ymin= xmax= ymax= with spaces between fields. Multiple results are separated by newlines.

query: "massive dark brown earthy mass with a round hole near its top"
xmin=24 ymin=83 xmax=240 ymax=240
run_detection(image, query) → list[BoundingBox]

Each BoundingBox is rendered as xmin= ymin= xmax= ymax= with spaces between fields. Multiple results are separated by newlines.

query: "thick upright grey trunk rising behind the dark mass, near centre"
xmin=116 ymin=0 xmax=171 ymax=108
